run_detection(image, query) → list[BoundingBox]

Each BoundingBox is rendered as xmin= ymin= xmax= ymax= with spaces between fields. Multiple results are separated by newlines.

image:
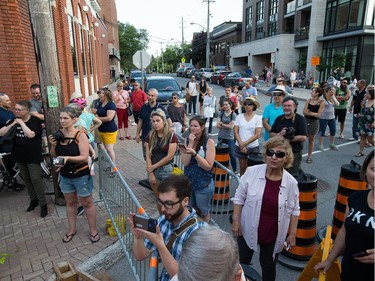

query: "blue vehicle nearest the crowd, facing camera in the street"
xmin=146 ymin=76 xmax=185 ymax=105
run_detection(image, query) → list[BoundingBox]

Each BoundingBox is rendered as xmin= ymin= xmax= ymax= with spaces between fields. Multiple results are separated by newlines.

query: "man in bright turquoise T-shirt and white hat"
xmin=262 ymin=85 xmax=287 ymax=141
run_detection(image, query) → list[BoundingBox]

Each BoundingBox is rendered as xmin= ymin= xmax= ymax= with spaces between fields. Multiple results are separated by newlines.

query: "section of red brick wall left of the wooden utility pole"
xmin=0 ymin=0 xmax=39 ymax=104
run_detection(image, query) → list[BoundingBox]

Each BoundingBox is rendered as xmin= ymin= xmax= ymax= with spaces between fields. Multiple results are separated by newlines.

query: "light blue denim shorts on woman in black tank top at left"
xmin=60 ymin=175 xmax=94 ymax=197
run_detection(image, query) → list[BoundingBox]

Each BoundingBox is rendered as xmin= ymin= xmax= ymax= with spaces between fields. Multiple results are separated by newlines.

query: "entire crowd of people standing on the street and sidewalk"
xmin=0 ymin=71 xmax=374 ymax=280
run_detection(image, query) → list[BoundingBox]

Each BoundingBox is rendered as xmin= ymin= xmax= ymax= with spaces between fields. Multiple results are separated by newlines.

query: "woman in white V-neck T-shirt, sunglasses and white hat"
xmin=234 ymin=97 xmax=262 ymax=176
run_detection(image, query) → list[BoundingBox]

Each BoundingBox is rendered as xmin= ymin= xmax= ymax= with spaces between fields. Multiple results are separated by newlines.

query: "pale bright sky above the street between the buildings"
xmin=116 ymin=0 xmax=243 ymax=55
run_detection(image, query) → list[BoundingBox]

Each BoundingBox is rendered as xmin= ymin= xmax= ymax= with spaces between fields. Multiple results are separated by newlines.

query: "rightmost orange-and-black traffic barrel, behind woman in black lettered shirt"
xmin=332 ymin=160 xmax=366 ymax=239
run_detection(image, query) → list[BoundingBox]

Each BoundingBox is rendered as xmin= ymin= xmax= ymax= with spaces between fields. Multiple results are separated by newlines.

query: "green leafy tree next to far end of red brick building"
xmin=118 ymin=22 xmax=149 ymax=72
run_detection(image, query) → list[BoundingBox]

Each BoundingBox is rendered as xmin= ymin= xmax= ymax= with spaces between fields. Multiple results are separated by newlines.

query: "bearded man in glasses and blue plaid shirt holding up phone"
xmin=128 ymin=175 xmax=206 ymax=281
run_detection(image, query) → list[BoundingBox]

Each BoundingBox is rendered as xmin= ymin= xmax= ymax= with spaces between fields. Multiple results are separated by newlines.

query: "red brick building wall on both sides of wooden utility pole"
xmin=0 ymin=0 xmax=117 ymax=104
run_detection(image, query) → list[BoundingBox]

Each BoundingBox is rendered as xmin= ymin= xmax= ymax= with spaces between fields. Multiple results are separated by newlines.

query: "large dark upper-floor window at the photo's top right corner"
xmin=324 ymin=0 xmax=365 ymax=35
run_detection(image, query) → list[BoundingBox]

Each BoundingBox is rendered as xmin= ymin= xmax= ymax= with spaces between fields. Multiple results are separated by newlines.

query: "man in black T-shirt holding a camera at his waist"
xmin=270 ymin=96 xmax=307 ymax=175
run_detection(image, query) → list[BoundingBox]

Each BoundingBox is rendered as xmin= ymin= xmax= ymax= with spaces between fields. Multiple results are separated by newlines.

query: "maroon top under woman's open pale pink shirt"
xmin=258 ymin=178 xmax=281 ymax=244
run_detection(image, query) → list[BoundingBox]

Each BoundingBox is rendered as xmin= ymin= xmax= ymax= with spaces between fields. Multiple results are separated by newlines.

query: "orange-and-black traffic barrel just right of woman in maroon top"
xmin=282 ymin=172 xmax=318 ymax=260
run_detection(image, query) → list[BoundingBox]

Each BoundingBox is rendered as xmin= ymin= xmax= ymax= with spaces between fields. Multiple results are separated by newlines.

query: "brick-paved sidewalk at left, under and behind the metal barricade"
xmin=0 ymin=95 xmax=157 ymax=281
